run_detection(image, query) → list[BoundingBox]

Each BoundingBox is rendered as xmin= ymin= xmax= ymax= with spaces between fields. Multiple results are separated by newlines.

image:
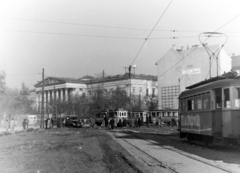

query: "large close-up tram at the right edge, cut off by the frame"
xmin=179 ymin=73 xmax=240 ymax=145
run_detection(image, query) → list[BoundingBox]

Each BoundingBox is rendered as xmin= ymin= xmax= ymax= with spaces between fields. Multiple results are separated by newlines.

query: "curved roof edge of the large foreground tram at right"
xmin=179 ymin=77 xmax=240 ymax=98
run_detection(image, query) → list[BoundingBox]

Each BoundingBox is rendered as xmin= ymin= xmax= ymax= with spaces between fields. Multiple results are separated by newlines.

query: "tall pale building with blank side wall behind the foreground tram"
xmin=156 ymin=44 xmax=232 ymax=109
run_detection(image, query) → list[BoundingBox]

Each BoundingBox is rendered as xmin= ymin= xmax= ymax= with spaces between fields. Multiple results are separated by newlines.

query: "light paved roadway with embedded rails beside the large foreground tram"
xmin=111 ymin=131 xmax=240 ymax=173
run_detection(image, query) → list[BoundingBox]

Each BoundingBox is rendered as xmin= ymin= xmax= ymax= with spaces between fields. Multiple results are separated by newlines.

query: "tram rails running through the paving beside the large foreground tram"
xmin=110 ymin=130 xmax=237 ymax=173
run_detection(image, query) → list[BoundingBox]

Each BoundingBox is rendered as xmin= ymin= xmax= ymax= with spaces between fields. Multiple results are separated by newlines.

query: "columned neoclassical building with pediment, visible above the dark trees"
xmin=33 ymin=73 xmax=158 ymax=113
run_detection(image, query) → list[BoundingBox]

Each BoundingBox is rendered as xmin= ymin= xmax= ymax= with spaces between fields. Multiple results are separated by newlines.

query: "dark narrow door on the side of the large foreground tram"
xmin=212 ymin=88 xmax=223 ymax=137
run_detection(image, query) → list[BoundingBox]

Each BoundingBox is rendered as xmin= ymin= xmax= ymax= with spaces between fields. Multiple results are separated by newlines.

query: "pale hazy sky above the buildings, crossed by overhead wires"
xmin=0 ymin=0 xmax=240 ymax=89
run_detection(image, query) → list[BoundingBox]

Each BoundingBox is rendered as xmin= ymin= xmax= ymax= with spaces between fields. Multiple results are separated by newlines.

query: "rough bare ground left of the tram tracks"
xmin=0 ymin=128 xmax=150 ymax=173
